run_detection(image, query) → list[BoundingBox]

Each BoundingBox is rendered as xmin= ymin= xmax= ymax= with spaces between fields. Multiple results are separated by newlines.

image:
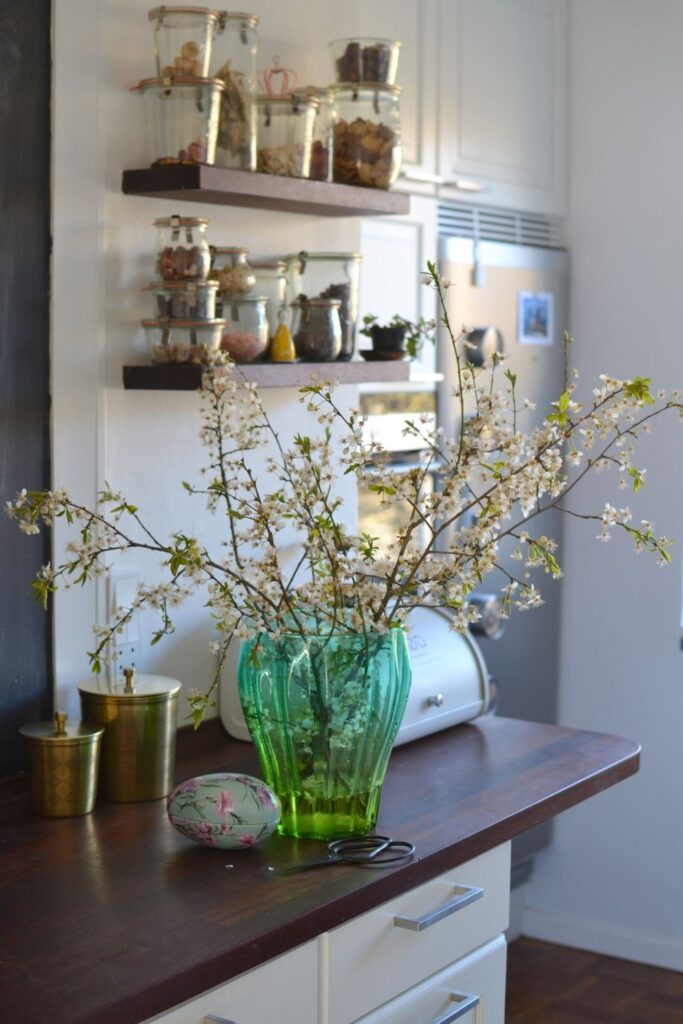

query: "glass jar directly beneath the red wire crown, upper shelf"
xmin=256 ymin=93 xmax=317 ymax=178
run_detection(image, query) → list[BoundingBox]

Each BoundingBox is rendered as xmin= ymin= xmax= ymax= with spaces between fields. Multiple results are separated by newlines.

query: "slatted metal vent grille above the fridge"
xmin=438 ymin=203 xmax=564 ymax=249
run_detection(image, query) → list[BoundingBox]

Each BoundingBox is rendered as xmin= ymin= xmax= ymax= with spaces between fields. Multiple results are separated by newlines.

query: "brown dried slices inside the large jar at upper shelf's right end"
xmin=333 ymin=118 xmax=397 ymax=188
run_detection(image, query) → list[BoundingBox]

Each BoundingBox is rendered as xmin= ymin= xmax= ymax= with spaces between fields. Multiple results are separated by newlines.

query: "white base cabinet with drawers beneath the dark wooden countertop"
xmin=146 ymin=843 xmax=510 ymax=1024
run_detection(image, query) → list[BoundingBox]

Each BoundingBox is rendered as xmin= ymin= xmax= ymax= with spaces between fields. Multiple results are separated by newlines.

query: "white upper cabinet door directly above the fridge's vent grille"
xmin=437 ymin=0 xmax=567 ymax=215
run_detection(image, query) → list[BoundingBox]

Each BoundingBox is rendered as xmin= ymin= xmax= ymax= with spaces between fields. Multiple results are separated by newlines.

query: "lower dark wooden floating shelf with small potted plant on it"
xmin=123 ymin=360 xmax=411 ymax=391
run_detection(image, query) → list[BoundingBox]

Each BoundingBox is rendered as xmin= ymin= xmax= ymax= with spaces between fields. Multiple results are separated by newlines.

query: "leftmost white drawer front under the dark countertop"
xmin=145 ymin=940 xmax=317 ymax=1024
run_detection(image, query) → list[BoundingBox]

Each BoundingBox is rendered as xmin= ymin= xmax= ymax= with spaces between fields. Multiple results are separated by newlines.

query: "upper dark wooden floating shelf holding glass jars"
xmin=123 ymin=164 xmax=411 ymax=217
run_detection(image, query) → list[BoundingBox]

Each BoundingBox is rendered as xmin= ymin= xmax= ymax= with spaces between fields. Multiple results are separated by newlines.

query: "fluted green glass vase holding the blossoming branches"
xmin=238 ymin=629 xmax=411 ymax=839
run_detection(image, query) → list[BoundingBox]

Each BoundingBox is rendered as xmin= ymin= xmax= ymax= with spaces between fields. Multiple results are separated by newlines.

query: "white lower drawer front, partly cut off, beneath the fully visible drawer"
xmin=357 ymin=935 xmax=507 ymax=1024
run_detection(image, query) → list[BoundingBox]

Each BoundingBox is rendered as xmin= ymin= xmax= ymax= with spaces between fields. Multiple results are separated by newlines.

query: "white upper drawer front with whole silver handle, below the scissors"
xmin=324 ymin=843 xmax=510 ymax=1024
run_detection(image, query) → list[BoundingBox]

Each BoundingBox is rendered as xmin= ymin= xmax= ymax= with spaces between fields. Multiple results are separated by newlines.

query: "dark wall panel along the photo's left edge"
xmin=0 ymin=0 xmax=52 ymax=774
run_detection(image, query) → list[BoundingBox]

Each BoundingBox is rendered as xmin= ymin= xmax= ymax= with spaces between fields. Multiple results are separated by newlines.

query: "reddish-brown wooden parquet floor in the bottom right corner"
xmin=505 ymin=938 xmax=683 ymax=1024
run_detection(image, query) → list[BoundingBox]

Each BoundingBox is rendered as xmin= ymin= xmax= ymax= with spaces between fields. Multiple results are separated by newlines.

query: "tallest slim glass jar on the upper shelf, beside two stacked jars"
xmin=211 ymin=10 xmax=258 ymax=171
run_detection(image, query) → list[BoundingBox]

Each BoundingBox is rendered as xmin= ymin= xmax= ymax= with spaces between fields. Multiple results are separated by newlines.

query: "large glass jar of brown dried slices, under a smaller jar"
xmin=332 ymin=85 xmax=400 ymax=188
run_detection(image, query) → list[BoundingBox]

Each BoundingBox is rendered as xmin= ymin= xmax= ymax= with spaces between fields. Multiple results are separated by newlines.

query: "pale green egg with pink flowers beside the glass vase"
xmin=166 ymin=772 xmax=280 ymax=850
